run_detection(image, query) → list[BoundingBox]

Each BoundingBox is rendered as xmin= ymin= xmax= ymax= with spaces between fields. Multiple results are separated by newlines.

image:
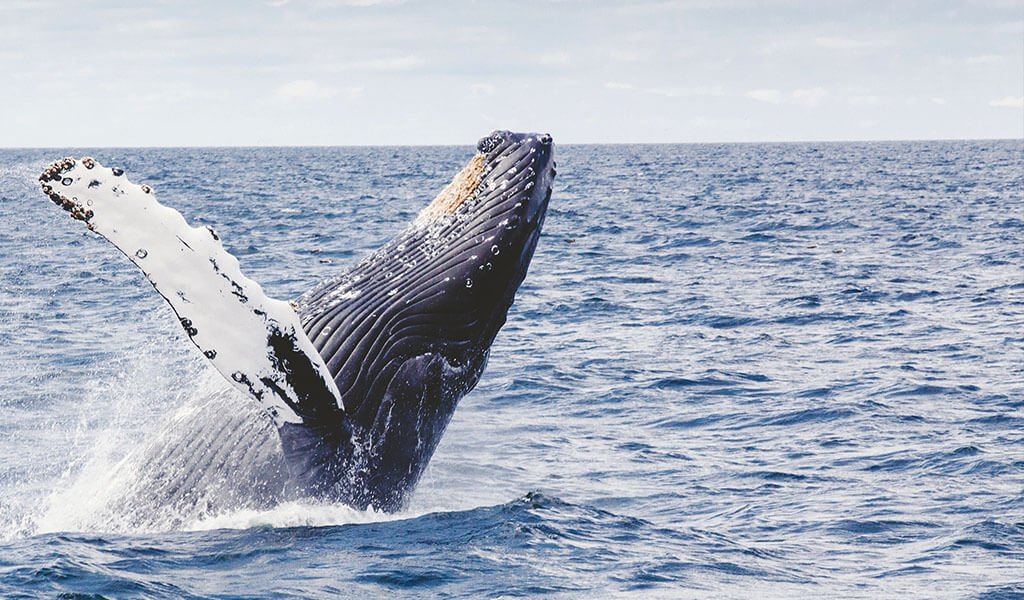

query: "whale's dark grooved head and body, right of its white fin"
xmin=280 ymin=132 xmax=555 ymax=510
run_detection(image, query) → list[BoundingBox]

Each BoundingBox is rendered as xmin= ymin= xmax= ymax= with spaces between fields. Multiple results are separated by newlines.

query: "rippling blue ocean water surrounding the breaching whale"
xmin=0 ymin=139 xmax=1024 ymax=599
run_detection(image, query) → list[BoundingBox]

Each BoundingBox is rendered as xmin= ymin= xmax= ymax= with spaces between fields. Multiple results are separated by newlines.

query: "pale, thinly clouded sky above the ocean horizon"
xmin=0 ymin=0 xmax=1024 ymax=147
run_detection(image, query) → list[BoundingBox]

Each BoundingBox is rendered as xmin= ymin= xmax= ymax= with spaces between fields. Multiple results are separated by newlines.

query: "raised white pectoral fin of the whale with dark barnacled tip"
xmin=40 ymin=158 xmax=343 ymax=427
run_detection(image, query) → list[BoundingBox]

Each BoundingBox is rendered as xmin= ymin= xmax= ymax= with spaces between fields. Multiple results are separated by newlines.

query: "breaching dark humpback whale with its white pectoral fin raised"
xmin=40 ymin=131 xmax=555 ymax=512
